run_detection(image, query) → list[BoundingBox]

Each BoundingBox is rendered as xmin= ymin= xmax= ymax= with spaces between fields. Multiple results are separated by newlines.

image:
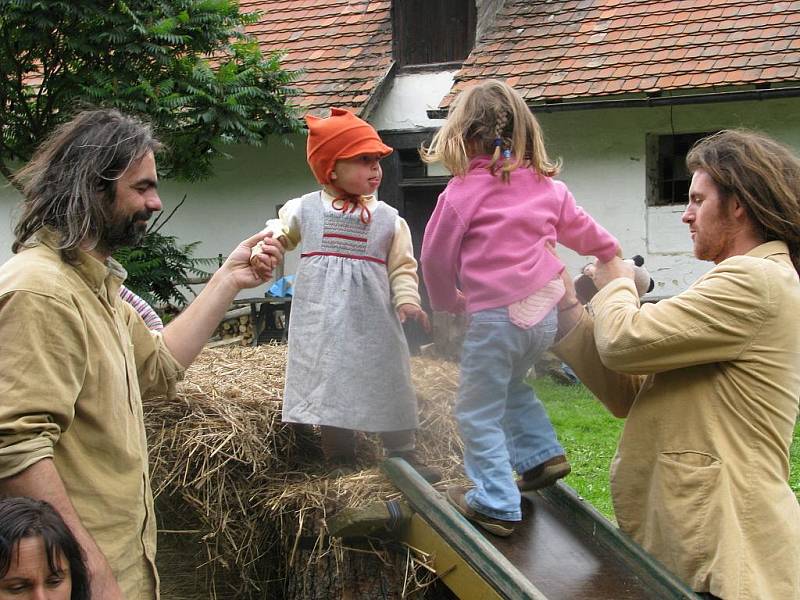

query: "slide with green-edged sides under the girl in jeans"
xmin=381 ymin=458 xmax=699 ymax=600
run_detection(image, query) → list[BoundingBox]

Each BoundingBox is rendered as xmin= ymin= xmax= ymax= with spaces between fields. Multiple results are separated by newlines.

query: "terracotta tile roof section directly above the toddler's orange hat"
xmin=239 ymin=0 xmax=393 ymax=114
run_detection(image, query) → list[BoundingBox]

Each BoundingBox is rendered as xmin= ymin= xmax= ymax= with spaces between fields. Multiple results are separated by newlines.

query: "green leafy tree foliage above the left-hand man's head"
xmin=0 ymin=0 xmax=300 ymax=180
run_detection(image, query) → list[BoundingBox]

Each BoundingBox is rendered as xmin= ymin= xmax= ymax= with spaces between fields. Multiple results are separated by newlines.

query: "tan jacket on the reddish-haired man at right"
xmin=554 ymin=242 xmax=800 ymax=600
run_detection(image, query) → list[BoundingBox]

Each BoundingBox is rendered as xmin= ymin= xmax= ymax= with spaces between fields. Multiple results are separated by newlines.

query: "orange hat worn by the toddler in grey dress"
xmin=306 ymin=108 xmax=392 ymax=185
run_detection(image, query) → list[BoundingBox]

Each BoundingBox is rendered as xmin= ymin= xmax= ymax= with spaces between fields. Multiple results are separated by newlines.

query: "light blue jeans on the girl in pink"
xmin=456 ymin=308 xmax=564 ymax=521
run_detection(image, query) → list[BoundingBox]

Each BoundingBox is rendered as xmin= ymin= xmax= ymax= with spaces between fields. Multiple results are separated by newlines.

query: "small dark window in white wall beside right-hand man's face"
xmin=647 ymin=131 xmax=713 ymax=206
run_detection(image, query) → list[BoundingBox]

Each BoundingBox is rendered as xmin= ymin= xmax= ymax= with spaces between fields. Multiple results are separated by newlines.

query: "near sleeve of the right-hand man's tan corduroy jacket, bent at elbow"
xmin=591 ymin=257 xmax=773 ymax=374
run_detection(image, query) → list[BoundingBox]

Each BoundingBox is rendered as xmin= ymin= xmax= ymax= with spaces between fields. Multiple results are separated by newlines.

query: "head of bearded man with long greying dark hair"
xmin=12 ymin=109 xmax=161 ymax=262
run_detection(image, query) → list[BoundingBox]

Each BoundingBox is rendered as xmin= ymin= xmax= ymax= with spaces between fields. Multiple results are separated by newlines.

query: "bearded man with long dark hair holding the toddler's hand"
xmin=0 ymin=110 xmax=281 ymax=600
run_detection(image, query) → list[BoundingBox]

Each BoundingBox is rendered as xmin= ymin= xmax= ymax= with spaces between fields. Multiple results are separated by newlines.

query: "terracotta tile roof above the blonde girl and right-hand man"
xmin=441 ymin=0 xmax=800 ymax=107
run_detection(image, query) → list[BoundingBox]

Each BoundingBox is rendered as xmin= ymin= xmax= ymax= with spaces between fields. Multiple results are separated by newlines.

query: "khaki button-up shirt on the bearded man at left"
xmin=0 ymin=232 xmax=182 ymax=600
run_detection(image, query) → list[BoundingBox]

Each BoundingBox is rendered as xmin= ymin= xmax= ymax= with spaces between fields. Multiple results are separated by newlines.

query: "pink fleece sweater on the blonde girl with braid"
xmin=421 ymin=156 xmax=619 ymax=313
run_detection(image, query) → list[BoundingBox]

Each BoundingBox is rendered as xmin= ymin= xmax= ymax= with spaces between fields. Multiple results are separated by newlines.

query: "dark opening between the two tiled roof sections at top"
xmin=392 ymin=0 xmax=476 ymax=67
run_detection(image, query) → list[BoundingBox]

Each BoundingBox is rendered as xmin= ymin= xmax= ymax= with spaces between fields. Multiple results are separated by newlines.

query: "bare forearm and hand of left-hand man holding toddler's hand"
xmin=164 ymin=231 xmax=283 ymax=367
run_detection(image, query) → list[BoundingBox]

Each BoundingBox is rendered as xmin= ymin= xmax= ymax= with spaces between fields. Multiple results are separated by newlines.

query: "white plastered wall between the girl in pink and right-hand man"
xmin=537 ymin=94 xmax=800 ymax=295
